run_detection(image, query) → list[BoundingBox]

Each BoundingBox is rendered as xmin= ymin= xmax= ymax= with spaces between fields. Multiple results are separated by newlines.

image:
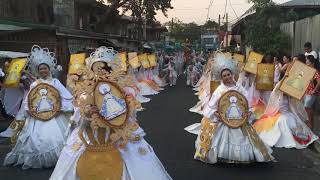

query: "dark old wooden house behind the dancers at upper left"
xmin=0 ymin=0 xmax=169 ymax=80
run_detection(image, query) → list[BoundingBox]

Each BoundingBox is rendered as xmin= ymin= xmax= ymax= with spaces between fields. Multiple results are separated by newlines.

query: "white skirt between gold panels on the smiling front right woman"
xmin=195 ymin=122 xmax=273 ymax=164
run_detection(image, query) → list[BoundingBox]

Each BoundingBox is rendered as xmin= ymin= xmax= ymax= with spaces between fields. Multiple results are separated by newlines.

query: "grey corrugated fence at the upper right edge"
xmin=280 ymin=14 xmax=320 ymax=55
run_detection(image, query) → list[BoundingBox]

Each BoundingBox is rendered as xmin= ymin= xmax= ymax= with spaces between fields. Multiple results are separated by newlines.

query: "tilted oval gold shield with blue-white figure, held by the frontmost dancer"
xmin=94 ymin=81 xmax=129 ymax=128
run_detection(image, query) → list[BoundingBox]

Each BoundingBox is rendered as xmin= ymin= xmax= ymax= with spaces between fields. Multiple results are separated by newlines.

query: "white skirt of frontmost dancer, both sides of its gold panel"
xmin=50 ymin=128 xmax=171 ymax=180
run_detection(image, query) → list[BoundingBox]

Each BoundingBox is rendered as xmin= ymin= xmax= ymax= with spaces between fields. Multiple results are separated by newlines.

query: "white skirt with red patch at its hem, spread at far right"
xmin=259 ymin=113 xmax=319 ymax=149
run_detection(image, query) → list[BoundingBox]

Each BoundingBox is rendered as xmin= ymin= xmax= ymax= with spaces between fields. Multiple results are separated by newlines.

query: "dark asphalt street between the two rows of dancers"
xmin=0 ymin=76 xmax=320 ymax=180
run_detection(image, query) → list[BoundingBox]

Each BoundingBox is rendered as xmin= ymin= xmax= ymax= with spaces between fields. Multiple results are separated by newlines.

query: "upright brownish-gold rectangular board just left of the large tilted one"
xmin=256 ymin=64 xmax=275 ymax=91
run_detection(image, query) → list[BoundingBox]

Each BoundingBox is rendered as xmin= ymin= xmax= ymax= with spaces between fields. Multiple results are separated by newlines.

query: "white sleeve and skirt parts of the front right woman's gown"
xmin=187 ymin=84 xmax=274 ymax=164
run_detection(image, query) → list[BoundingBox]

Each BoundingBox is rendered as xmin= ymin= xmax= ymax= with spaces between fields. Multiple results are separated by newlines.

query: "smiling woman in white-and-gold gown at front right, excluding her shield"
xmin=186 ymin=55 xmax=274 ymax=164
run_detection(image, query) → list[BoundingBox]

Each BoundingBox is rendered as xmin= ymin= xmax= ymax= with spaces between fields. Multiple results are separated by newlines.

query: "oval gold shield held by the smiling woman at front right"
xmin=215 ymin=90 xmax=249 ymax=128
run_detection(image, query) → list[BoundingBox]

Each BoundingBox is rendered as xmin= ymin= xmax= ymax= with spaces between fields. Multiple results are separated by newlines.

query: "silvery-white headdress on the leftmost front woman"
xmin=28 ymin=45 xmax=62 ymax=76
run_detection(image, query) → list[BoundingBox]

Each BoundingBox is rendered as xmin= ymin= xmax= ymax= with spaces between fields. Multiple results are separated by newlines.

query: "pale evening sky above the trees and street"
xmin=156 ymin=0 xmax=290 ymax=24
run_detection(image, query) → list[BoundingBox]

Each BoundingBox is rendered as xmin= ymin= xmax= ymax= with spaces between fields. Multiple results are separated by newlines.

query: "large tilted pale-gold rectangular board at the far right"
xmin=280 ymin=61 xmax=317 ymax=100
